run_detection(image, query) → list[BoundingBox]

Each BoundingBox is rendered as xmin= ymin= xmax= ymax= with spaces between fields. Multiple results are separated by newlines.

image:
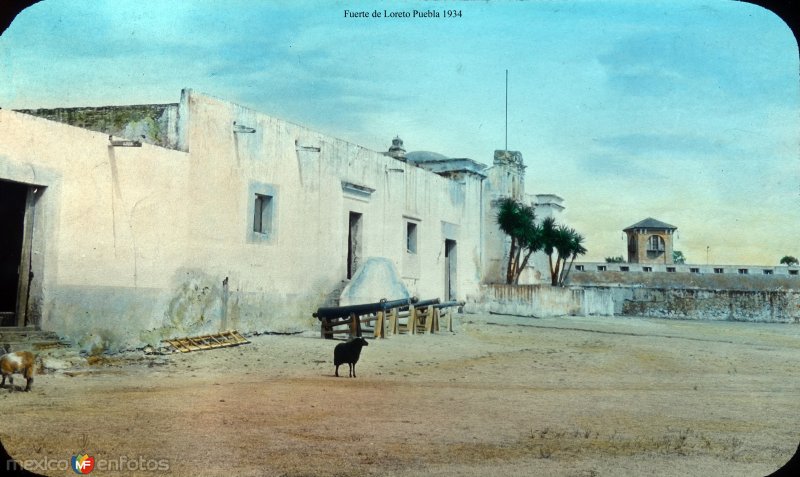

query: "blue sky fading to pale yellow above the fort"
xmin=0 ymin=0 xmax=800 ymax=265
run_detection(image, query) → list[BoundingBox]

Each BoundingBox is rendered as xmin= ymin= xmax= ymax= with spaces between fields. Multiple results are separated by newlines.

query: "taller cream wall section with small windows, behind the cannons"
xmin=180 ymin=92 xmax=481 ymax=322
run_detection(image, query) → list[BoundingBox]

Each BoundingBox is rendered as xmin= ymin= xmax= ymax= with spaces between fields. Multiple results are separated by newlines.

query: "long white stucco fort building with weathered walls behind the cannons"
xmin=0 ymin=90 xmax=561 ymax=348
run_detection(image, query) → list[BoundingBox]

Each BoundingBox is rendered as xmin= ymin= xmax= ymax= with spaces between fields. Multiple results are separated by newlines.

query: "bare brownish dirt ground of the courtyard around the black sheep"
xmin=0 ymin=315 xmax=800 ymax=477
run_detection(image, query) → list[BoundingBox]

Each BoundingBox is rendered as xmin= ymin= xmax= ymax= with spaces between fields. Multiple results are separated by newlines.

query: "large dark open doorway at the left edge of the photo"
xmin=0 ymin=180 xmax=28 ymax=326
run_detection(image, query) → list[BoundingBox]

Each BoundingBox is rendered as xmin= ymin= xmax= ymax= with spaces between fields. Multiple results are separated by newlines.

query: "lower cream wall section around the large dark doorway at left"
xmin=0 ymin=106 xmax=189 ymax=350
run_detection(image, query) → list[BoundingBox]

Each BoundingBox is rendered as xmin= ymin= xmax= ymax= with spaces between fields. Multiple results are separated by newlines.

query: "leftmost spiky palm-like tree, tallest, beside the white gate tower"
xmin=497 ymin=197 xmax=544 ymax=285
